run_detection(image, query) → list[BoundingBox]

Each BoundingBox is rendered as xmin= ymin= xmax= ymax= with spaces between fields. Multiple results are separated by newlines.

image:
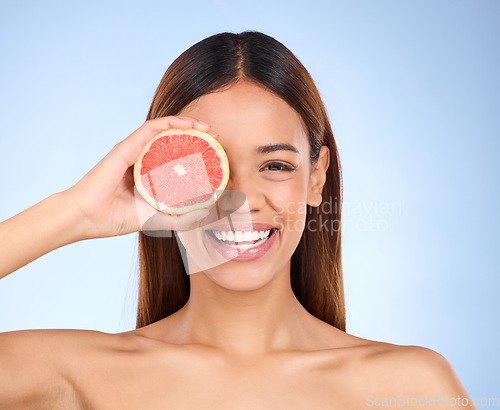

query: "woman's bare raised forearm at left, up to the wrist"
xmin=0 ymin=193 xmax=85 ymax=279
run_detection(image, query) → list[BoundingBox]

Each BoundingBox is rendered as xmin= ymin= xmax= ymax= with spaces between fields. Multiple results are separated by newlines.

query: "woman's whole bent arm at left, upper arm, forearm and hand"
xmin=0 ymin=117 xmax=217 ymax=410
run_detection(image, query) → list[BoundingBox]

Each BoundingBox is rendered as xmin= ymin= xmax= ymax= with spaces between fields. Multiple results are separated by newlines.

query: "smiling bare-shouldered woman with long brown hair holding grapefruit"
xmin=0 ymin=31 xmax=471 ymax=409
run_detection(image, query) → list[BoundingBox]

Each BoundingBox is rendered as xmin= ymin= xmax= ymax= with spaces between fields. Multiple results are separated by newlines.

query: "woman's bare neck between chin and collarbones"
xmin=161 ymin=263 xmax=323 ymax=357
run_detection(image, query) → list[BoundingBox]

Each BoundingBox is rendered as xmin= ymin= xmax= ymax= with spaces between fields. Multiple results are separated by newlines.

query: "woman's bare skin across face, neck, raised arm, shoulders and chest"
xmin=0 ymin=81 xmax=474 ymax=410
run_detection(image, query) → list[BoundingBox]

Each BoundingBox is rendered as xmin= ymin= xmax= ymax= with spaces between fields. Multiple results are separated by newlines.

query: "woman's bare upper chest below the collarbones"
xmin=71 ymin=355 xmax=360 ymax=410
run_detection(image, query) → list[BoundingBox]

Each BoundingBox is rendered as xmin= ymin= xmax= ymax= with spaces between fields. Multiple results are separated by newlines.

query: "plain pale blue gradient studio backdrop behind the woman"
xmin=0 ymin=0 xmax=500 ymax=398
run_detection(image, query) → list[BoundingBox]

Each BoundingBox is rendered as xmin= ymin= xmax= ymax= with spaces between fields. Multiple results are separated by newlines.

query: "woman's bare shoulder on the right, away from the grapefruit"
xmin=334 ymin=335 xmax=468 ymax=398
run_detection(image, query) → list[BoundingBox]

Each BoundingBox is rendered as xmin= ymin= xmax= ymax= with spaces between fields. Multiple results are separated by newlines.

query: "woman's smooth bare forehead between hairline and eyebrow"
xmin=178 ymin=81 xmax=308 ymax=155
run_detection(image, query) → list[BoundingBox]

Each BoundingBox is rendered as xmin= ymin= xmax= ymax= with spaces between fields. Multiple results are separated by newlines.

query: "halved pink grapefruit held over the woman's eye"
xmin=134 ymin=128 xmax=229 ymax=215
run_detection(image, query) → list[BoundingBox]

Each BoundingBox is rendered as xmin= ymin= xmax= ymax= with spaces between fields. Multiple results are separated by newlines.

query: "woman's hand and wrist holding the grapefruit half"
xmin=62 ymin=116 xmax=218 ymax=239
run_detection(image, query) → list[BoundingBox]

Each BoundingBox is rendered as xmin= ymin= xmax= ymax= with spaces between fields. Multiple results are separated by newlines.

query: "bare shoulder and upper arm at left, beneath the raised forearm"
xmin=0 ymin=329 xmax=133 ymax=409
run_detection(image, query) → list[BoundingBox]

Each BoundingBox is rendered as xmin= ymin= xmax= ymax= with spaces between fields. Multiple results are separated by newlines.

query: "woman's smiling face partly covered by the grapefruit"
xmin=177 ymin=81 xmax=329 ymax=290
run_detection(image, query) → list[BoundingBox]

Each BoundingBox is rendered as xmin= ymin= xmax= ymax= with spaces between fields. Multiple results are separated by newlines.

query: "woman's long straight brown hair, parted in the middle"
xmin=136 ymin=31 xmax=345 ymax=331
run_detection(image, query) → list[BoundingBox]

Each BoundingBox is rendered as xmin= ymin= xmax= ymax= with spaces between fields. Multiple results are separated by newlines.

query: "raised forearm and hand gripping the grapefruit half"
xmin=0 ymin=116 xmax=217 ymax=279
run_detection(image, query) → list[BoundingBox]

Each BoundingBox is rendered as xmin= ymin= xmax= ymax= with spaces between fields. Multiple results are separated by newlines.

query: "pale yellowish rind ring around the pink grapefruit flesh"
xmin=134 ymin=128 xmax=229 ymax=215
